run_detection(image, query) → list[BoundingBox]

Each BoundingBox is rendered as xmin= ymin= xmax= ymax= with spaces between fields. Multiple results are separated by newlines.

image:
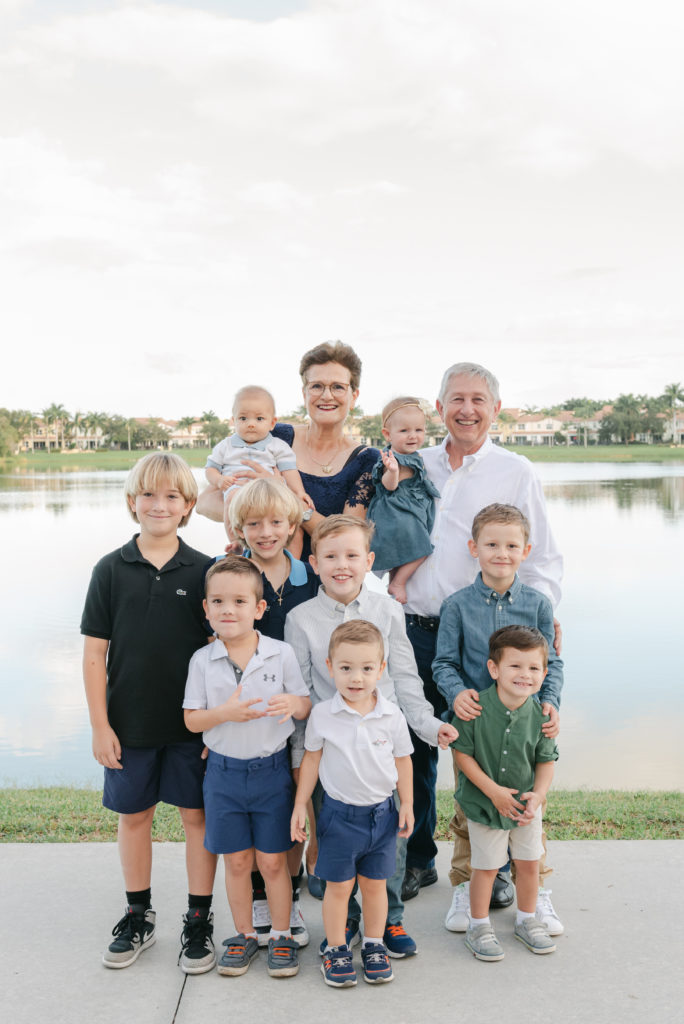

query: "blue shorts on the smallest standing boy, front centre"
xmin=315 ymin=793 xmax=399 ymax=882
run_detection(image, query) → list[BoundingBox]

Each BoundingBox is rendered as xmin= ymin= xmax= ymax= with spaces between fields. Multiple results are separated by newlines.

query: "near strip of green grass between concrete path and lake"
xmin=0 ymin=787 xmax=684 ymax=843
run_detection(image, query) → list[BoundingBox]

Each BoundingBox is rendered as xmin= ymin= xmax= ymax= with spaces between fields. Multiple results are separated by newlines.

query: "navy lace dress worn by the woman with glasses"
xmin=272 ymin=423 xmax=380 ymax=561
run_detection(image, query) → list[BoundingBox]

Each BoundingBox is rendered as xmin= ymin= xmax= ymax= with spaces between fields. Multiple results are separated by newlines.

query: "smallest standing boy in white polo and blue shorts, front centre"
xmin=292 ymin=620 xmax=414 ymax=988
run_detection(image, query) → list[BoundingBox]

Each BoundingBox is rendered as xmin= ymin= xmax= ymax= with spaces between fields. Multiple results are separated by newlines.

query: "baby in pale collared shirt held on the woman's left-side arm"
xmin=205 ymin=385 xmax=312 ymax=553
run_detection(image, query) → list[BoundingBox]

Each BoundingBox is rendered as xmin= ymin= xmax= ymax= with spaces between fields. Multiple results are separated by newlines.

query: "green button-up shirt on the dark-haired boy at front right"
xmin=452 ymin=685 xmax=558 ymax=828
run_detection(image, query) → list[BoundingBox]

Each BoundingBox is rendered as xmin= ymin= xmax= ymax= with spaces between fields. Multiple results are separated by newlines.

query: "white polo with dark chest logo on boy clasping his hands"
xmin=183 ymin=631 xmax=309 ymax=760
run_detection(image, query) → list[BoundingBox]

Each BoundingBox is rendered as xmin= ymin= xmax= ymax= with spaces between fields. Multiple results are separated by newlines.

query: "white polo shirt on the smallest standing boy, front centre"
xmin=304 ymin=690 xmax=414 ymax=807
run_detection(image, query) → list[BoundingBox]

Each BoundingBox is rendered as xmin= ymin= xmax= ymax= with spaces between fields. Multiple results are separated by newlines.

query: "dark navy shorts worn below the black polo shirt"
xmin=102 ymin=740 xmax=207 ymax=814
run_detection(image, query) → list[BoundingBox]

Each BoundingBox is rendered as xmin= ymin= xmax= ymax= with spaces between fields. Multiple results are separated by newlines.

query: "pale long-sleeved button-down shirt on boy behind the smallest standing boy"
xmin=285 ymin=584 xmax=442 ymax=746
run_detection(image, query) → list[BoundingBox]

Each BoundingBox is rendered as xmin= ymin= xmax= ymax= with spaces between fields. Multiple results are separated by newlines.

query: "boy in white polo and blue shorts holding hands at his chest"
xmin=183 ymin=555 xmax=311 ymax=978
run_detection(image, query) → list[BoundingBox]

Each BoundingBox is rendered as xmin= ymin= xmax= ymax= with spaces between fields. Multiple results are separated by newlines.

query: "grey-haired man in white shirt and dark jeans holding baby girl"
xmin=402 ymin=362 xmax=562 ymax=934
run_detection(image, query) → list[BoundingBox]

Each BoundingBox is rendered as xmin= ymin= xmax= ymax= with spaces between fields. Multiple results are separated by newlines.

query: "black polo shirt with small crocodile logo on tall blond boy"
xmin=81 ymin=534 xmax=208 ymax=746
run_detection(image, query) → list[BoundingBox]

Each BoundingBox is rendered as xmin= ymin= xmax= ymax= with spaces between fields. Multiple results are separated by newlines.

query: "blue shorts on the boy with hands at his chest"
xmin=204 ymin=746 xmax=294 ymax=853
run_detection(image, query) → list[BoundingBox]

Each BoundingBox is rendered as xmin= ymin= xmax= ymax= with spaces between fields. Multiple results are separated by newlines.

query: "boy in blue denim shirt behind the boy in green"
xmin=432 ymin=504 xmax=563 ymax=935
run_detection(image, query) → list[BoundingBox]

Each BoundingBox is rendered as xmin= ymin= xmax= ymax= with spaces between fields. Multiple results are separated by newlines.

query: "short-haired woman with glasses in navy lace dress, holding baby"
xmin=198 ymin=341 xmax=379 ymax=558
